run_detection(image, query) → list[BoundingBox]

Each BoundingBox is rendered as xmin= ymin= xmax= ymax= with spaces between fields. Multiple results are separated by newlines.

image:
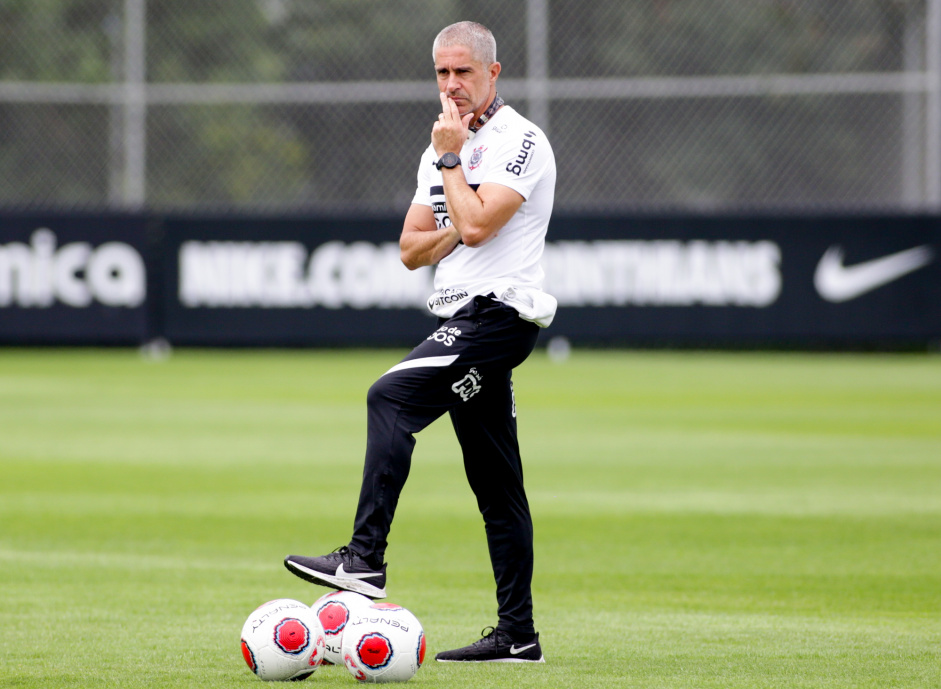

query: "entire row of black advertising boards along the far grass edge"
xmin=0 ymin=214 xmax=941 ymax=348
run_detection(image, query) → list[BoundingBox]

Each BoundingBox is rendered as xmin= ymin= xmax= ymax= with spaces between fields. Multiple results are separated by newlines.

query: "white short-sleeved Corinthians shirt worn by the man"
xmin=412 ymin=105 xmax=556 ymax=327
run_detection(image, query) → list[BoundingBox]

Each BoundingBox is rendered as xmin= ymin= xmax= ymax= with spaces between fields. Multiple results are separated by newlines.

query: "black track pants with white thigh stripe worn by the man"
xmin=350 ymin=297 xmax=539 ymax=634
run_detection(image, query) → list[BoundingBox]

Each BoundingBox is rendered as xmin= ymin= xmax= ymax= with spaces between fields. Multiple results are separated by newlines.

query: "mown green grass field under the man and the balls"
xmin=0 ymin=350 xmax=941 ymax=689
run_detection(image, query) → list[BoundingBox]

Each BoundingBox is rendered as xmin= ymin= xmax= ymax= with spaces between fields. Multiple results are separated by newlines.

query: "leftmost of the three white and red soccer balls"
xmin=242 ymin=598 xmax=325 ymax=680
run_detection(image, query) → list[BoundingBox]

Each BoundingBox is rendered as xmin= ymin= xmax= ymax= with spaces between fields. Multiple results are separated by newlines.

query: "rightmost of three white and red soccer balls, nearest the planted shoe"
xmin=341 ymin=603 xmax=425 ymax=683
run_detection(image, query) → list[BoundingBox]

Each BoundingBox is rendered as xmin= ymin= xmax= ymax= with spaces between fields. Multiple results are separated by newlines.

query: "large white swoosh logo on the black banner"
xmin=814 ymin=244 xmax=934 ymax=303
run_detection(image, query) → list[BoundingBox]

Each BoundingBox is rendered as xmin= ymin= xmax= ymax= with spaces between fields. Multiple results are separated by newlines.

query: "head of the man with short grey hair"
xmin=432 ymin=22 xmax=500 ymax=122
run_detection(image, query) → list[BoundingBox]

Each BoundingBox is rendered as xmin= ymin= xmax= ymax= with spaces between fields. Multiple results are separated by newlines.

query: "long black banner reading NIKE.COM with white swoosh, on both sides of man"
xmin=163 ymin=216 xmax=941 ymax=347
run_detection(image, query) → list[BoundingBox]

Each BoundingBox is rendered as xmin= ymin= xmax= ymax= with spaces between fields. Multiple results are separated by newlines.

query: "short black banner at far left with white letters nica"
xmin=0 ymin=213 xmax=150 ymax=344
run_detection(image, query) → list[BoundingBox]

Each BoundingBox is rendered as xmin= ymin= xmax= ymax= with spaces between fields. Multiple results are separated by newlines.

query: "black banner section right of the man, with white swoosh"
xmin=545 ymin=216 xmax=941 ymax=346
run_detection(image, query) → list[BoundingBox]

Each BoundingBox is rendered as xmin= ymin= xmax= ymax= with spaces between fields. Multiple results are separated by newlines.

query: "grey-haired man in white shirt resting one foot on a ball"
xmin=285 ymin=22 xmax=556 ymax=662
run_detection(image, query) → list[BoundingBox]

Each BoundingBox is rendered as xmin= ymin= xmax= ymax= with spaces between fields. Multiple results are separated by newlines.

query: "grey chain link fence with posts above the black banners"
xmin=0 ymin=0 xmax=941 ymax=214
